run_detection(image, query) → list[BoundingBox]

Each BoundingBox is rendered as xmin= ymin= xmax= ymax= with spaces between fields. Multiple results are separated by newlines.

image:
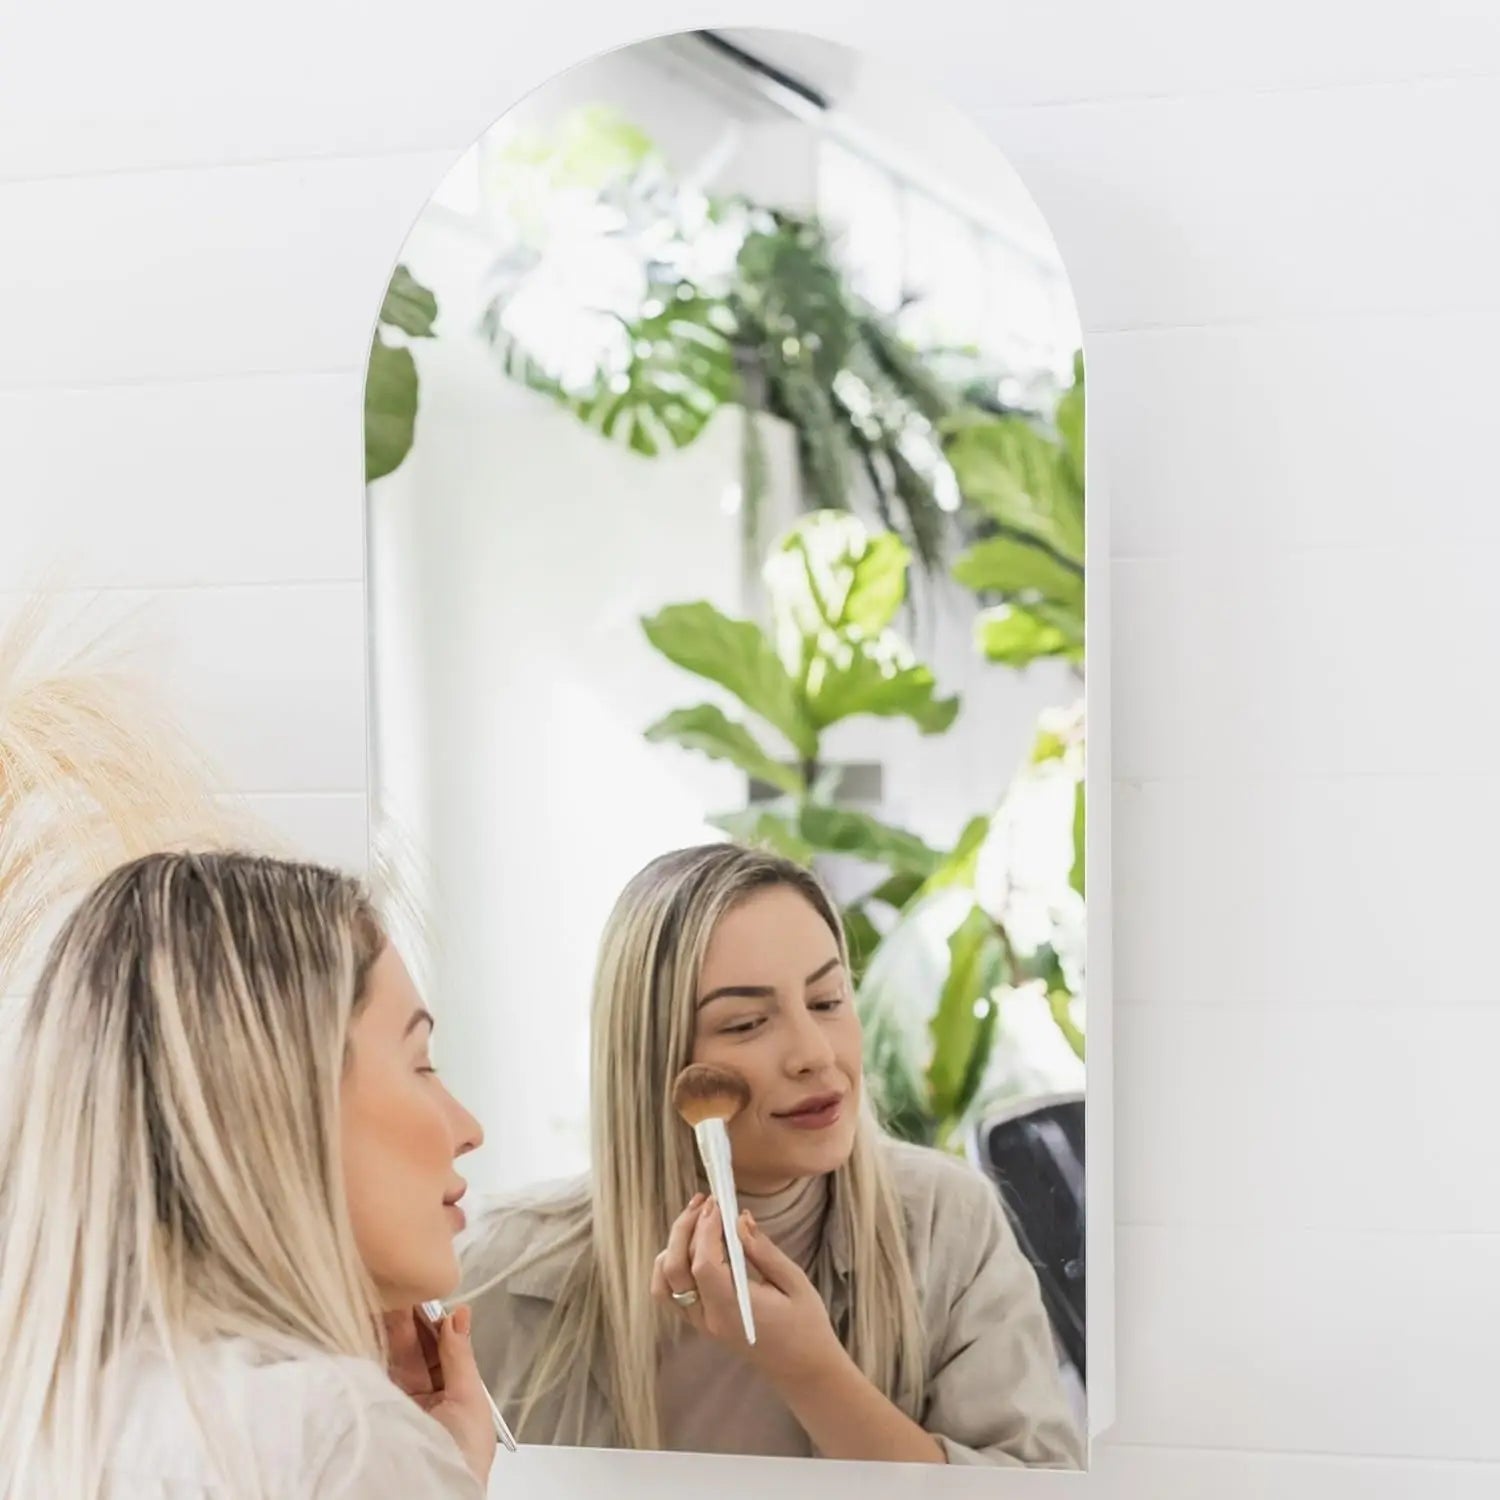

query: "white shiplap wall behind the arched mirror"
xmin=0 ymin=0 xmax=1500 ymax=1500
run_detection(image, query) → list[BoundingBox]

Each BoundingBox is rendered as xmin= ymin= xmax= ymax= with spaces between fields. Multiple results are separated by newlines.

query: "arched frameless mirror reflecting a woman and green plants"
xmin=366 ymin=32 xmax=1088 ymax=1467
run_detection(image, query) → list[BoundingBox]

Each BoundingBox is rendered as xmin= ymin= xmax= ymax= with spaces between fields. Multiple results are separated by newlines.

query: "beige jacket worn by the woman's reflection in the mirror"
xmin=462 ymin=1142 xmax=1083 ymax=1469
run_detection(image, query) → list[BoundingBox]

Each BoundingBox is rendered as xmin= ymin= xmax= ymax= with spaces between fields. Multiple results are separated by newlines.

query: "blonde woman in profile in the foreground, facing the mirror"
xmin=0 ymin=854 xmax=495 ymax=1500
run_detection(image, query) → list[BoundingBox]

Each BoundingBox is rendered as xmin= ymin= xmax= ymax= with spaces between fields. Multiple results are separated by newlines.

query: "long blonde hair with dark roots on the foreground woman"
xmin=0 ymin=854 xmax=383 ymax=1500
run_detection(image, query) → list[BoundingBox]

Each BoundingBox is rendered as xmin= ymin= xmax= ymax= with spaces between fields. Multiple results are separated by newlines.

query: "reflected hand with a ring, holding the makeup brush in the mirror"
xmin=651 ymin=1194 xmax=843 ymax=1388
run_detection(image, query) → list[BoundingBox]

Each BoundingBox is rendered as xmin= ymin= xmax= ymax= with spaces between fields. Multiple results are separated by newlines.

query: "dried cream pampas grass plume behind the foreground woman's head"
xmin=0 ymin=593 xmax=270 ymax=995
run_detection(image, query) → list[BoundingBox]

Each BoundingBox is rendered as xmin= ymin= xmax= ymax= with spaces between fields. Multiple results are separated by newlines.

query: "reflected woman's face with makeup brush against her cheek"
xmin=693 ymin=885 xmax=863 ymax=1194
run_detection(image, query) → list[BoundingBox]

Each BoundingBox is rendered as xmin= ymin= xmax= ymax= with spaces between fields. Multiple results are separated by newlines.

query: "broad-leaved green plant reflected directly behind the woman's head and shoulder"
xmin=644 ymin=512 xmax=1083 ymax=1148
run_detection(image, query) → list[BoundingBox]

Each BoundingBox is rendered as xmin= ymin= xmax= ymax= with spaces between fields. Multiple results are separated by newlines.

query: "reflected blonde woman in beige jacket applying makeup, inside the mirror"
xmin=461 ymin=845 xmax=1082 ymax=1467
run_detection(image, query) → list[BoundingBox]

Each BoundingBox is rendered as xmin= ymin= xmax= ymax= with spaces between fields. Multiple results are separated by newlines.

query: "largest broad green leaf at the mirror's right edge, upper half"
xmin=947 ymin=417 xmax=1083 ymax=566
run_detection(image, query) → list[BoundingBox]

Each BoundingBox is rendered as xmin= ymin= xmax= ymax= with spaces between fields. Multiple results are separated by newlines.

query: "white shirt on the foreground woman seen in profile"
xmin=95 ymin=1341 xmax=483 ymax=1500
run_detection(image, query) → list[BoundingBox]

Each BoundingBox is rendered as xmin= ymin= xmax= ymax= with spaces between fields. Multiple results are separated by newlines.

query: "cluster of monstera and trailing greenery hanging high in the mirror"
xmin=482 ymin=108 xmax=959 ymax=569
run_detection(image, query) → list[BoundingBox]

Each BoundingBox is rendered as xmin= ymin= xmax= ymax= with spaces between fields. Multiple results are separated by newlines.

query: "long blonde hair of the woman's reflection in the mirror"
xmin=495 ymin=843 xmax=926 ymax=1449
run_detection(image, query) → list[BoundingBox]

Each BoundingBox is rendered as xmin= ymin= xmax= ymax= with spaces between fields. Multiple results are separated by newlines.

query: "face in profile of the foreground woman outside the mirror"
xmin=342 ymin=944 xmax=485 ymax=1311
